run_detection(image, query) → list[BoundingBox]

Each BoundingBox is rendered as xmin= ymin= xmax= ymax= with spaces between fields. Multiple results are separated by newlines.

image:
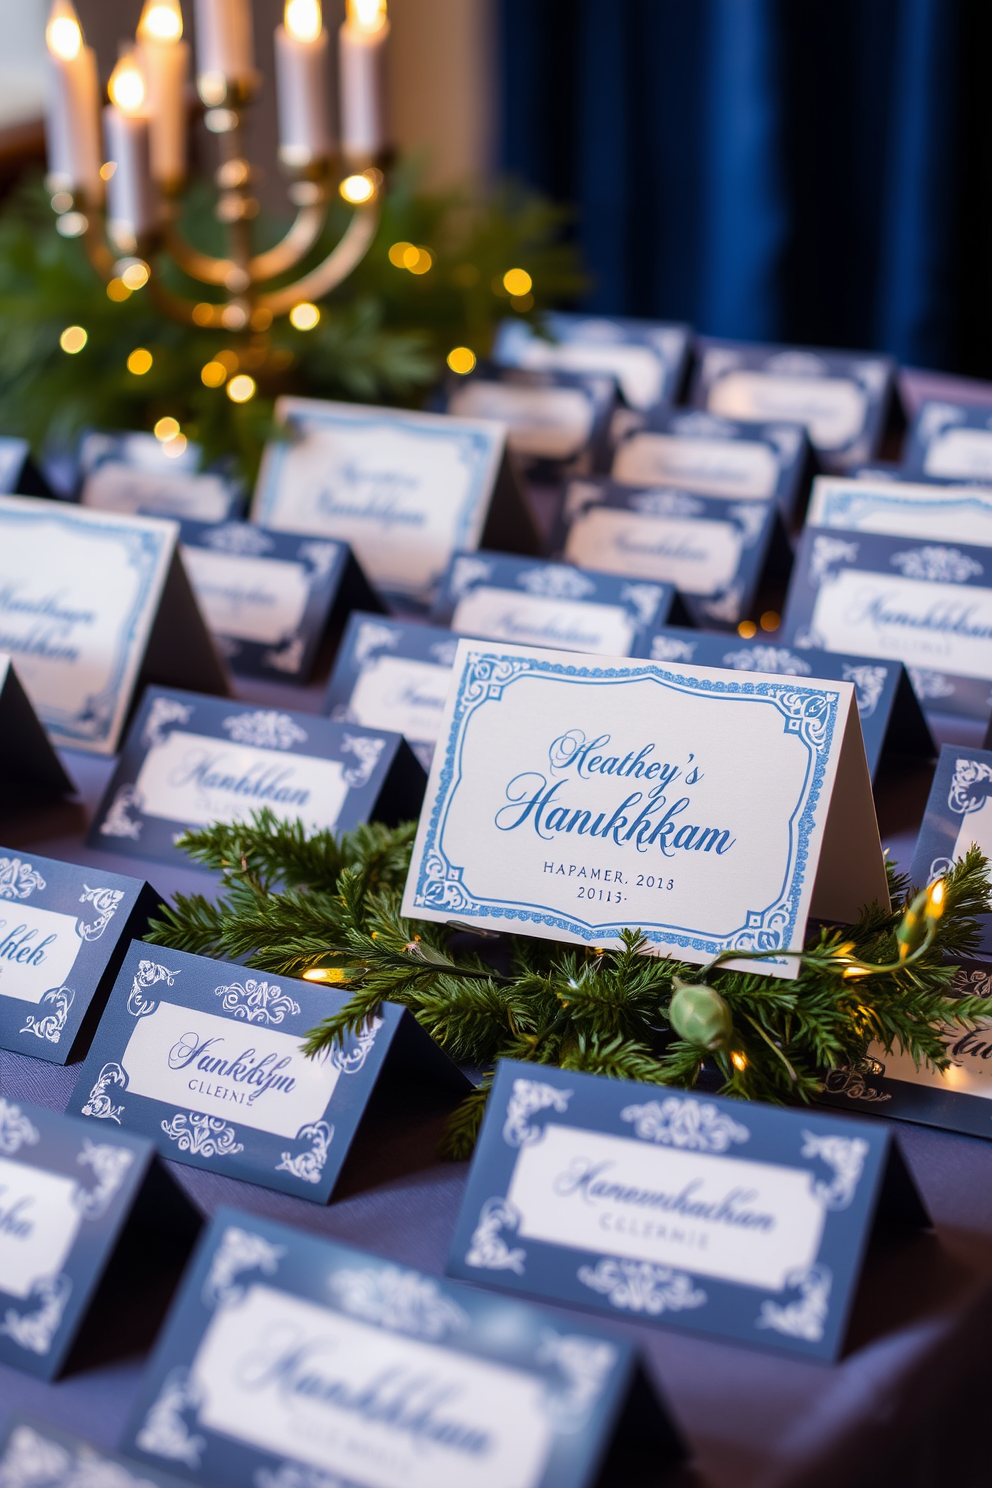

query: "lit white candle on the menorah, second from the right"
xmin=275 ymin=0 xmax=333 ymax=167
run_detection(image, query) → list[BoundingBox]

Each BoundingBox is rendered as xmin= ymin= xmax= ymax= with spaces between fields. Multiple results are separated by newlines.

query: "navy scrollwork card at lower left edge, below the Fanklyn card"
xmin=0 ymin=1097 xmax=198 ymax=1379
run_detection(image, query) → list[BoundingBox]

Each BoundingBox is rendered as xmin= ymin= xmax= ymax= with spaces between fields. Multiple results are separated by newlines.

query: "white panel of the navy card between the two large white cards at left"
xmin=183 ymin=545 xmax=309 ymax=646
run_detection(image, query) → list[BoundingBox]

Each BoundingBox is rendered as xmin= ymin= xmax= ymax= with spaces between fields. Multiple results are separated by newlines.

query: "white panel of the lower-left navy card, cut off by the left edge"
xmin=0 ymin=1158 xmax=83 ymax=1298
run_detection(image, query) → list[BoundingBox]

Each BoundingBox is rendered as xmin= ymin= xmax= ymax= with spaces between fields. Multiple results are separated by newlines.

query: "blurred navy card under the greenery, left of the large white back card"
xmin=79 ymin=433 xmax=244 ymax=522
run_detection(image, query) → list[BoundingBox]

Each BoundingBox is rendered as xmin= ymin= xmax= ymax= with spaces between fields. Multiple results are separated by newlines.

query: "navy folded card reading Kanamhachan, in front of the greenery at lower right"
xmin=448 ymin=1059 xmax=928 ymax=1359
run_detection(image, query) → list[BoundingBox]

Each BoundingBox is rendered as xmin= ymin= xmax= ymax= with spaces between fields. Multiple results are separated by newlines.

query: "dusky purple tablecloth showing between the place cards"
xmin=0 ymin=363 xmax=992 ymax=1488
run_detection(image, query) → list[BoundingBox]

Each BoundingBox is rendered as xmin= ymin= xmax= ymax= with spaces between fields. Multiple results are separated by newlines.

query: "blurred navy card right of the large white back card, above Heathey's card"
xmin=553 ymin=481 xmax=784 ymax=629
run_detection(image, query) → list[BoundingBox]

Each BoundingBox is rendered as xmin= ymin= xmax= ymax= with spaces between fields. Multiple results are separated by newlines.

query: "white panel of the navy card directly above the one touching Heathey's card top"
xmin=565 ymin=506 xmax=742 ymax=594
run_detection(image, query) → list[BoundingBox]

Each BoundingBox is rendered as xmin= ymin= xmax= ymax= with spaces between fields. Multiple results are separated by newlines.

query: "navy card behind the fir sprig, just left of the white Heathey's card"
xmin=86 ymin=687 xmax=425 ymax=868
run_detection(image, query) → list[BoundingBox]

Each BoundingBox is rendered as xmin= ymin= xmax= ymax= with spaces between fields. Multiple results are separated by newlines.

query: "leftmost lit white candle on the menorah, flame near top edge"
xmin=45 ymin=0 xmax=103 ymax=201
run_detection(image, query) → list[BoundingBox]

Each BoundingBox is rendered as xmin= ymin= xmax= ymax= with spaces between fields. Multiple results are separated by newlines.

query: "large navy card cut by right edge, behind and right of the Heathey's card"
xmin=781 ymin=527 xmax=992 ymax=722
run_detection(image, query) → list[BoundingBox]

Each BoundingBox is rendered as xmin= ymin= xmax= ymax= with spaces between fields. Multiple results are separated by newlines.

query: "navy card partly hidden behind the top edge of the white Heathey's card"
xmin=431 ymin=552 xmax=677 ymax=656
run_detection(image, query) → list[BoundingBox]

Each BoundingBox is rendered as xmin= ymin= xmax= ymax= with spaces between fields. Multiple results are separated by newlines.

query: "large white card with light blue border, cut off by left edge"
xmin=0 ymin=496 xmax=228 ymax=754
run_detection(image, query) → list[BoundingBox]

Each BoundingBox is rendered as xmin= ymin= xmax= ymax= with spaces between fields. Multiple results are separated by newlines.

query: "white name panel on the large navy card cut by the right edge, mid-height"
xmin=811 ymin=568 xmax=992 ymax=677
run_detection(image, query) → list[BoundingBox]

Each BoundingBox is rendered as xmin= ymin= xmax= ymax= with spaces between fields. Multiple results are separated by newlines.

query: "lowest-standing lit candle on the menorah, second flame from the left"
xmin=103 ymin=54 xmax=156 ymax=253
